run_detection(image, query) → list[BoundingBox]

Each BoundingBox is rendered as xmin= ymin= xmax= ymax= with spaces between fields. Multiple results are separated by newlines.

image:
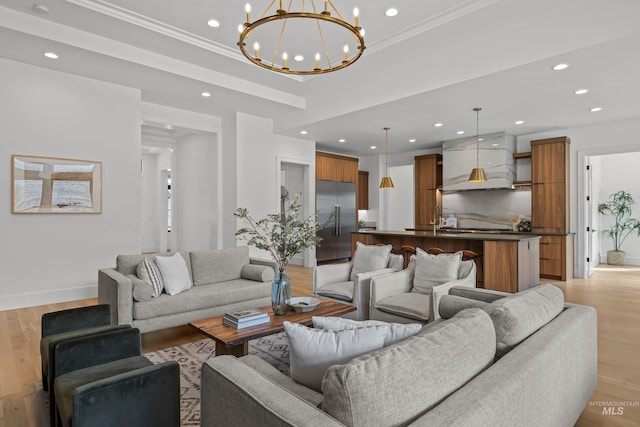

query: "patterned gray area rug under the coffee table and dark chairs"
xmin=33 ymin=332 xmax=289 ymax=426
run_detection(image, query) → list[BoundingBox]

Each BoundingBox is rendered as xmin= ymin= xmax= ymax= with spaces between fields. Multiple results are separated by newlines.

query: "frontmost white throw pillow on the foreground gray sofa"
xmin=283 ymin=322 xmax=389 ymax=392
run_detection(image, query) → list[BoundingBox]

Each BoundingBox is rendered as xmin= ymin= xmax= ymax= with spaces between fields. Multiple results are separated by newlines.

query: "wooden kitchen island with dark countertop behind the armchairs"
xmin=351 ymin=230 xmax=540 ymax=292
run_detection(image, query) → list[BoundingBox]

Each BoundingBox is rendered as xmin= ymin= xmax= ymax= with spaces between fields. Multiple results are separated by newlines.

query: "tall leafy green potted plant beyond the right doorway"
xmin=598 ymin=190 xmax=640 ymax=265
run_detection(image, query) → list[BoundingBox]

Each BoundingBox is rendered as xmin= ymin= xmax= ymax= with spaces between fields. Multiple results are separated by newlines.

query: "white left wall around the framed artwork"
xmin=0 ymin=59 xmax=141 ymax=310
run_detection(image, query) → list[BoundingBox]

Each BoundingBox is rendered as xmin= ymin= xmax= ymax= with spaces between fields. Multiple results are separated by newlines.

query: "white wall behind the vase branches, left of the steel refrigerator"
xmin=234 ymin=113 xmax=316 ymax=265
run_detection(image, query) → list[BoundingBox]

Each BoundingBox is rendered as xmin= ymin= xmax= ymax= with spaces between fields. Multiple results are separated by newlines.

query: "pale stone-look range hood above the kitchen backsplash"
xmin=442 ymin=132 xmax=516 ymax=191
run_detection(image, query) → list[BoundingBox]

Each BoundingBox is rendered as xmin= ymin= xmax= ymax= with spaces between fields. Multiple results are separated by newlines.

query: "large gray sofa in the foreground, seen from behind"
xmin=201 ymin=285 xmax=597 ymax=427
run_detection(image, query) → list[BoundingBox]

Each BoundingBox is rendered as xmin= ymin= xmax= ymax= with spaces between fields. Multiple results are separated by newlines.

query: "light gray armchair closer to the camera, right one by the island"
xmin=369 ymin=249 xmax=476 ymax=323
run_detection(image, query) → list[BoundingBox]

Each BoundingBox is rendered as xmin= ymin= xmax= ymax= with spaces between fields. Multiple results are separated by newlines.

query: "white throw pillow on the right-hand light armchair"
xmin=412 ymin=248 xmax=462 ymax=295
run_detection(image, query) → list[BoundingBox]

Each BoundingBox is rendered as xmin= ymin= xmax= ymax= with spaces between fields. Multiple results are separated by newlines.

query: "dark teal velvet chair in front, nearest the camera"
xmin=52 ymin=328 xmax=180 ymax=427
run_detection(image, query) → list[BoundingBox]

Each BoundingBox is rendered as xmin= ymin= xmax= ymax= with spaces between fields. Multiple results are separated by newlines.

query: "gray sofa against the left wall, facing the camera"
xmin=98 ymin=246 xmax=275 ymax=332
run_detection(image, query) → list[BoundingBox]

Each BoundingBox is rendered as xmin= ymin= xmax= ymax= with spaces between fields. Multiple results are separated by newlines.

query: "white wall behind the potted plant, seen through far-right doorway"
xmin=594 ymin=152 xmax=640 ymax=265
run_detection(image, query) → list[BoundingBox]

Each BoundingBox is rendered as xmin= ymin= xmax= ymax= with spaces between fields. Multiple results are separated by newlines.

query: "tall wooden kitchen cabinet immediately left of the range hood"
xmin=414 ymin=154 xmax=442 ymax=229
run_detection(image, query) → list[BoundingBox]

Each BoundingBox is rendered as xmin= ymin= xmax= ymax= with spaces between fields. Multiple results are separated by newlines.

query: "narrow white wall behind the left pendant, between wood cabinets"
xmin=384 ymin=165 xmax=415 ymax=230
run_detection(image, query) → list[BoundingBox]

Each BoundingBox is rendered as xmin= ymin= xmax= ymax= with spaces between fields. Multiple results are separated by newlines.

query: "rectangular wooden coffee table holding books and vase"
xmin=189 ymin=298 xmax=356 ymax=357
